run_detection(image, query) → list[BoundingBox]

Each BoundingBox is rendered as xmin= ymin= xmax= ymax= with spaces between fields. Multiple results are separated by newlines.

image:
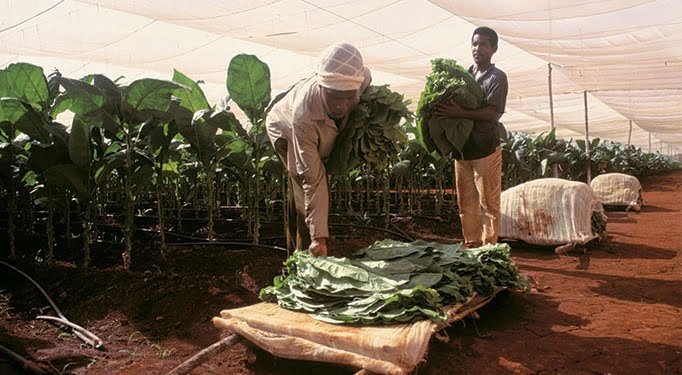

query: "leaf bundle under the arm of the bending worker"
xmin=326 ymin=85 xmax=413 ymax=175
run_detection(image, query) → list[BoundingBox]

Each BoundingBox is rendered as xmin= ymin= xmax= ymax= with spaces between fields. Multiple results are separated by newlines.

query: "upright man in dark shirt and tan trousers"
xmin=435 ymin=27 xmax=509 ymax=248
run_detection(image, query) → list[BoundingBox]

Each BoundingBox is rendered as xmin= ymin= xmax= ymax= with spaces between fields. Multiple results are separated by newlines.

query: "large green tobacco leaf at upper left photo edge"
xmin=0 ymin=63 xmax=50 ymax=110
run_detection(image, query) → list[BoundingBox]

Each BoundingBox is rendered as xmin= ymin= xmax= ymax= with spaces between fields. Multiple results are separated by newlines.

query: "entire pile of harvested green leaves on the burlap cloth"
xmin=260 ymin=240 xmax=527 ymax=324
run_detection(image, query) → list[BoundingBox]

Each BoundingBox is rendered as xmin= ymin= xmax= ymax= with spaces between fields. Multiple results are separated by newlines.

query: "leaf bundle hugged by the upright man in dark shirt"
xmin=417 ymin=58 xmax=484 ymax=156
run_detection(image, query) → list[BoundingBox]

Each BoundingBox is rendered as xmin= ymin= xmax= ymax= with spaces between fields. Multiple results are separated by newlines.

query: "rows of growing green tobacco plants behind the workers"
xmin=0 ymin=59 xmax=679 ymax=269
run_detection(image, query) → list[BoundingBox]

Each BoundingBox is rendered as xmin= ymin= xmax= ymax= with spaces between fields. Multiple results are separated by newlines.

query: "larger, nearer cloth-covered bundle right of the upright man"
xmin=500 ymin=178 xmax=605 ymax=246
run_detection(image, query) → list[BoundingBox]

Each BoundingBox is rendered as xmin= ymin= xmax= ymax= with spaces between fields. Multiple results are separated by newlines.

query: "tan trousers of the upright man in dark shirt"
xmin=455 ymin=146 xmax=502 ymax=247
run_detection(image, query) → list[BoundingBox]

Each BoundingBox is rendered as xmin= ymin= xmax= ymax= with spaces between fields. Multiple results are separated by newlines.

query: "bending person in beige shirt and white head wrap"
xmin=266 ymin=43 xmax=371 ymax=256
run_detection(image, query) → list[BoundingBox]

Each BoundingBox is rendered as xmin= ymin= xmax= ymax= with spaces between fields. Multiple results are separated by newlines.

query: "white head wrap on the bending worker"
xmin=316 ymin=43 xmax=365 ymax=91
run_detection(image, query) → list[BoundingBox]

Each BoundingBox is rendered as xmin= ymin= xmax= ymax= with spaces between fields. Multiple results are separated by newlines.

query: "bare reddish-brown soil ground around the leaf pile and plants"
xmin=0 ymin=171 xmax=682 ymax=375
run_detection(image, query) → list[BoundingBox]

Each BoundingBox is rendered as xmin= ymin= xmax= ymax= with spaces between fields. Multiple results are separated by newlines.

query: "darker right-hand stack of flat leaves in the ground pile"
xmin=354 ymin=239 xmax=528 ymax=305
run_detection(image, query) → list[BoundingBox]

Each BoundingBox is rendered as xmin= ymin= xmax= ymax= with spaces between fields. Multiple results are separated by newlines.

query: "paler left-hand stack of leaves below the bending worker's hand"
xmin=260 ymin=251 xmax=446 ymax=324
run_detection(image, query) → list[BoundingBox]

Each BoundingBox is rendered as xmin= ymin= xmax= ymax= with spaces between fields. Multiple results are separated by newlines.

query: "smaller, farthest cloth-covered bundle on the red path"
xmin=590 ymin=173 xmax=642 ymax=211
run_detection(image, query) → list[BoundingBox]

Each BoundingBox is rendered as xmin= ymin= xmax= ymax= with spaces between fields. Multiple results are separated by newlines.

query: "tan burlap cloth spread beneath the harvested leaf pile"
xmin=213 ymin=296 xmax=499 ymax=375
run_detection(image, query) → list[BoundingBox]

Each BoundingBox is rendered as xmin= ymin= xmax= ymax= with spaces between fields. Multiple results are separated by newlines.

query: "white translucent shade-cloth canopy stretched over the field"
xmin=0 ymin=0 xmax=682 ymax=153
